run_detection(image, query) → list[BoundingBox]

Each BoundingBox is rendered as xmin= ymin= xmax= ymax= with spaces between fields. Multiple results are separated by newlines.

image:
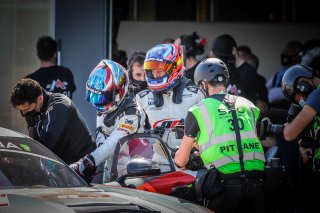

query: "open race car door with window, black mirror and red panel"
xmin=107 ymin=133 xmax=202 ymax=204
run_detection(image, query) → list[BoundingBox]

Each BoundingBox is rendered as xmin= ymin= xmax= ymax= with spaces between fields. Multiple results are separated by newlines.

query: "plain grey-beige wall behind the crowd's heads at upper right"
xmin=118 ymin=21 xmax=320 ymax=78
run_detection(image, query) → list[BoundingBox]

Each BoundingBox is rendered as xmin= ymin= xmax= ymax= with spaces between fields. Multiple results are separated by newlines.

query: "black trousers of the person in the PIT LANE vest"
xmin=208 ymin=177 xmax=267 ymax=213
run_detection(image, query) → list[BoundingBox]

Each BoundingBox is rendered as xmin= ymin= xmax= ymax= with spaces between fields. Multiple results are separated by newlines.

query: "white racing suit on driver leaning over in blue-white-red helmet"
xmin=91 ymin=96 xmax=145 ymax=183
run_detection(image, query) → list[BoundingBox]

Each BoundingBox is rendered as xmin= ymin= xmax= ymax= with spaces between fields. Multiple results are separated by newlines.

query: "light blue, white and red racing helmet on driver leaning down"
xmin=86 ymin=59 xmax=129 ymax=112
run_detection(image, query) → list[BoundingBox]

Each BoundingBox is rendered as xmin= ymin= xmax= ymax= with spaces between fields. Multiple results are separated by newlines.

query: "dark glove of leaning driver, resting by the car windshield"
xmin=69 ymin=155 xmax=96 ymax=184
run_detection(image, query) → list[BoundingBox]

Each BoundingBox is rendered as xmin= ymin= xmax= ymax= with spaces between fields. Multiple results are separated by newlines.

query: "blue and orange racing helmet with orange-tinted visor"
xmin=143 ymin=44 xmax=185 ymax=92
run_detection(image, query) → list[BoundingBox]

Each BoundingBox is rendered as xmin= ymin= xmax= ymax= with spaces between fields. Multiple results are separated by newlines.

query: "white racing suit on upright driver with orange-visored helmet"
xmin=136 ymin=78 xmax=205 ymax=171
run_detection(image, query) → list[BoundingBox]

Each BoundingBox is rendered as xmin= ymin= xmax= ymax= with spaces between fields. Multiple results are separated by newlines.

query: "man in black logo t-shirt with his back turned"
xmin=25 ymin=36 xmax=76 ymax=98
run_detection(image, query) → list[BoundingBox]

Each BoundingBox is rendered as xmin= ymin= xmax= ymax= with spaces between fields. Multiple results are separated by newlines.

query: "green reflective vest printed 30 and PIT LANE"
xmin=189 ymin=97 xmax=265 ymax=174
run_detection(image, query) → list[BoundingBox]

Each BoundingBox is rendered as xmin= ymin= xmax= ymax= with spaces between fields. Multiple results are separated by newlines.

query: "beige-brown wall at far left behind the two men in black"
xmin=0 ymin=0 xmax=50 ymax=133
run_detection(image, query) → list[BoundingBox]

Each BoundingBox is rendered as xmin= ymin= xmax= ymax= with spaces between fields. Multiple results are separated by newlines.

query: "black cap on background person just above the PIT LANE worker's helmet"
xmin=211 ymin=34 xmax=237 ymax=57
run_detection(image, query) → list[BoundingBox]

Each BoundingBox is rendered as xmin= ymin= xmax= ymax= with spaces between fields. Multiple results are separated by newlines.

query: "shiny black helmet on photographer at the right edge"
xmin=281 ymin=64 xmax=314 ymax=102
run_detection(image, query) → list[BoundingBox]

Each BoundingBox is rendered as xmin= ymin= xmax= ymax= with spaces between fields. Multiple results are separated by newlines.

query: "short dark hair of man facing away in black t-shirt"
xmin=37 ymin=36 xmax=58 ymax=61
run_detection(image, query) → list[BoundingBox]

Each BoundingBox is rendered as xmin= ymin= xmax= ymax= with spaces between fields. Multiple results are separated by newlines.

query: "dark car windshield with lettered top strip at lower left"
xmin=0 ymin=137 xmax=87 ymax=189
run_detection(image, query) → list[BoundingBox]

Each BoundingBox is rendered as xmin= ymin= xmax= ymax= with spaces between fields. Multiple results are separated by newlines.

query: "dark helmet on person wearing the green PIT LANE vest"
xmin=194 ymin=58 xmax=229 ymax=85
